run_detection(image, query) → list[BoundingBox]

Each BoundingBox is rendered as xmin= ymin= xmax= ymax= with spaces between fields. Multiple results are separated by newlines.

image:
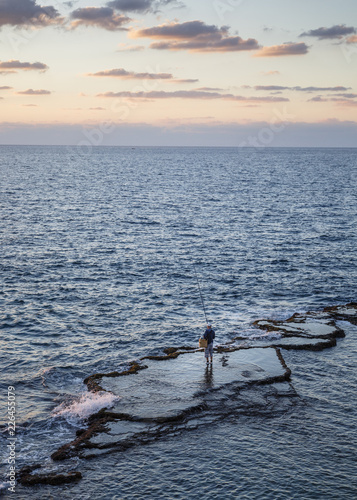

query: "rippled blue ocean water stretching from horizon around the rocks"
xmin=0 ymin=146 xmax=357 ymax=500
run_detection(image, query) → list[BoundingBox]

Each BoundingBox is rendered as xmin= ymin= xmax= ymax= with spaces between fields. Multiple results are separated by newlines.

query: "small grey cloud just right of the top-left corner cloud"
xmin=71 ymin=7 xmax=131 ymax=31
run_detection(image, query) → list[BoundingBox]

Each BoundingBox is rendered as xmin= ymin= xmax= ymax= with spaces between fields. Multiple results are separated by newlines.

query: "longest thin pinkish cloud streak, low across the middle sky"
xmin=97 ymin=90 xmax=289 ymax=103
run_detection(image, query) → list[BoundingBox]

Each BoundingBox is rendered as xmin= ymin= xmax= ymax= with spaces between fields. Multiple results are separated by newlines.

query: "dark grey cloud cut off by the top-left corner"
xmin=0 ymin=0 xmax=63 ymax=28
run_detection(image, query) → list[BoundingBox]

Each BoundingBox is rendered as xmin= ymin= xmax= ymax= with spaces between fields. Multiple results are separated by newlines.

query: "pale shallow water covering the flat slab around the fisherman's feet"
xmin=101 ymin=348 xmax=285 ymax=420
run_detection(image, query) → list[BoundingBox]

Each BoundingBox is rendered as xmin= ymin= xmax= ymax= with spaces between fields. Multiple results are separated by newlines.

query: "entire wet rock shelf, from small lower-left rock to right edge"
xmin=19 ymin=303 xmax=357 ymax=486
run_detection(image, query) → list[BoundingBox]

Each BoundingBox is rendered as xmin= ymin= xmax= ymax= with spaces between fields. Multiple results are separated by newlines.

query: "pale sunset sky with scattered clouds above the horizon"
xmin=0 ymin=0 xmax=357 ymax=146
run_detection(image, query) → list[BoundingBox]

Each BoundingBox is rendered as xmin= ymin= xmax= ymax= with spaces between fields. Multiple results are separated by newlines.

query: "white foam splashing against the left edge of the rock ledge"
xmin=52 ymin=392 xmax=119 ymax=420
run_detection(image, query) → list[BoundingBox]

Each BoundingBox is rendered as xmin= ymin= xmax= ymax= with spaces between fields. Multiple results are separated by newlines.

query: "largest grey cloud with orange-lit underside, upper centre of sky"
xmin=130 ymin=21 xmax=259 ymax=52
